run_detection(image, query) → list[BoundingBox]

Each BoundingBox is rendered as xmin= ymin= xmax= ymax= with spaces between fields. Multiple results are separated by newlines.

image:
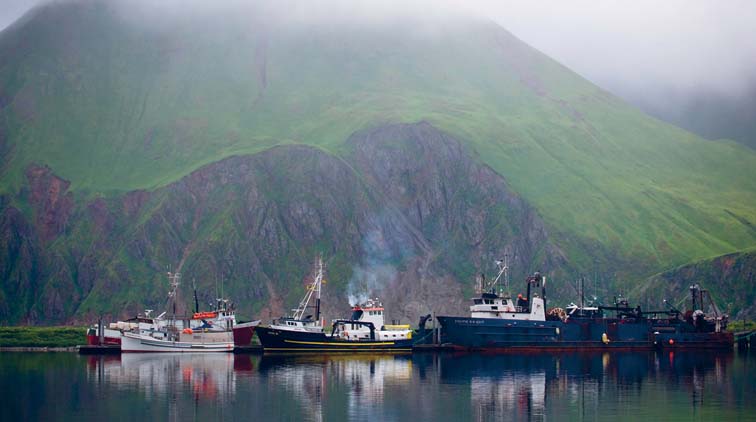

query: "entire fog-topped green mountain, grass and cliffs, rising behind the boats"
xmin=0 ymin=1 xmax=756 ymax=322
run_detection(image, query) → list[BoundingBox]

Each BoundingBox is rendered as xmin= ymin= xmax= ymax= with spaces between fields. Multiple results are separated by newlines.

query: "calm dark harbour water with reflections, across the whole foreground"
xmin=0 ymin=352 xmax=756 ymax=422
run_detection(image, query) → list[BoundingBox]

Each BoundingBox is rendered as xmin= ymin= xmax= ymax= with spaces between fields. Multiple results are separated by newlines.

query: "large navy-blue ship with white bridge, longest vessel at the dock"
xmin=437 ymin=261 xmax=733 ymax=352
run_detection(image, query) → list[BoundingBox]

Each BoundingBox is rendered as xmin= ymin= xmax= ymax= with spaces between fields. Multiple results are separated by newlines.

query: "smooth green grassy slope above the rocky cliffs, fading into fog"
xmin=0 ymin=2 xmax=756 ymax=274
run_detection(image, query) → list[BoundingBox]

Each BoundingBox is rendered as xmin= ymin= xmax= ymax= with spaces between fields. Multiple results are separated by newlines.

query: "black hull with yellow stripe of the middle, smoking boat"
xmin=255 ymin=327 xmax=413 ymax=353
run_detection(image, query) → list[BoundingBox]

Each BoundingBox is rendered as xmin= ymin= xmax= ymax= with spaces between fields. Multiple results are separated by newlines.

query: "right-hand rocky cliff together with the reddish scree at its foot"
xmin=348 ymin=123 xmax=567 ymax=318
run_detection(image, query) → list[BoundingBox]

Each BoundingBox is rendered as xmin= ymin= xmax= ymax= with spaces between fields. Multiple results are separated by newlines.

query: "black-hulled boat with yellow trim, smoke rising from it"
xmin=255 ymin=261 xmax=413 ymax=353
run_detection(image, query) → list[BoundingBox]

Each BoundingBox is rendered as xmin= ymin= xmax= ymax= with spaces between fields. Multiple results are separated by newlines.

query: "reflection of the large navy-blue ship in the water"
xmin=434 ymin=352 xmax=733 ymax=420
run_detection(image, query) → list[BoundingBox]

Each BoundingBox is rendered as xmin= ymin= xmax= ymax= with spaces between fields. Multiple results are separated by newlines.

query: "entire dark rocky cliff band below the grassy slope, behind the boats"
xmin=0 ymin=123 xmax=568 ymax=323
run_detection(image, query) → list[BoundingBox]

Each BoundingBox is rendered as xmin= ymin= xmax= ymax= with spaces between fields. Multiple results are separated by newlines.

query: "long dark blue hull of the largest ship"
xmin=437 ymin=316 xmax=733 ymax=353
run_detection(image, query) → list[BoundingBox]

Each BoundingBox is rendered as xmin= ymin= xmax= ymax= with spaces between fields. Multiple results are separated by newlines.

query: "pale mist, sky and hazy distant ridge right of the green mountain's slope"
xmin=484 ymin=0 xmax=756 ymax=146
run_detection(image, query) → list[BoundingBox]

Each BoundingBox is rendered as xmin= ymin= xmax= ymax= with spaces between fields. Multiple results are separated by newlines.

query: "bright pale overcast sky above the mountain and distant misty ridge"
xmin=0 ymin=0 xmax=756 ymax=102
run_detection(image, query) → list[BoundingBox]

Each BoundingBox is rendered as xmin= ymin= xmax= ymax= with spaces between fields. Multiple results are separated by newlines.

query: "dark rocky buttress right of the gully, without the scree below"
xmin=350 ymin=123 xmax=565 ymax=276
